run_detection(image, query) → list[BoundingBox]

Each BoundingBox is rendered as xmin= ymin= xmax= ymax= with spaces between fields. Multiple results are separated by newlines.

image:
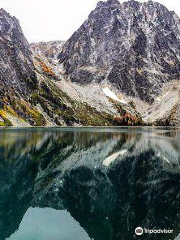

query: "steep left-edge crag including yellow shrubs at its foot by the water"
xmin=0 ymin=9 xmax=42 ymax=126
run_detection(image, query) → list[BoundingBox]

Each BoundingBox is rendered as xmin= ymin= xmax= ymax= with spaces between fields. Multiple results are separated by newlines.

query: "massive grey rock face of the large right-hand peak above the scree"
xmin=58 ymin=0 xmax=180 ymax=103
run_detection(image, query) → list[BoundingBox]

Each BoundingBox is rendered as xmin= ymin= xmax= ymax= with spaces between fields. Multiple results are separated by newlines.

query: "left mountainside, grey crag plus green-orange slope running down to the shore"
xmin=0 ymin=9 xmax=142 ymax=126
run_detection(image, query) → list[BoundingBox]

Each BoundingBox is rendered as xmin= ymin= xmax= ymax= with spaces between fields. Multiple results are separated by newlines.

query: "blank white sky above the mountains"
xmin=0 ymin=0 xmax=180 ymax=43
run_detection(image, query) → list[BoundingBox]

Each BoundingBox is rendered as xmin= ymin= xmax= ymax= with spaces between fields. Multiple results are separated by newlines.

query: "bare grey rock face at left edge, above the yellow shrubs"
xmin=0 ymin=9 xmax=37 ymax=97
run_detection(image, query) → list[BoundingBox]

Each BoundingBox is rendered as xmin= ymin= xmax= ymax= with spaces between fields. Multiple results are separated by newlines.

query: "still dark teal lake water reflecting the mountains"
xmin=0 ymin=128 xmax=180 ymax=240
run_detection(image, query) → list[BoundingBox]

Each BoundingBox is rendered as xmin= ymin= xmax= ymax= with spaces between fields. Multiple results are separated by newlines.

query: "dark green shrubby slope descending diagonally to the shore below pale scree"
xmin=30 ymin=76 xmax=113 ymax=126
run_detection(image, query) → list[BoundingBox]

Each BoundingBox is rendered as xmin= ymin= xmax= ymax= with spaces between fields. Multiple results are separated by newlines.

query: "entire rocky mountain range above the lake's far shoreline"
xmin=0 ymin=0 xmax=180 ymax=126
